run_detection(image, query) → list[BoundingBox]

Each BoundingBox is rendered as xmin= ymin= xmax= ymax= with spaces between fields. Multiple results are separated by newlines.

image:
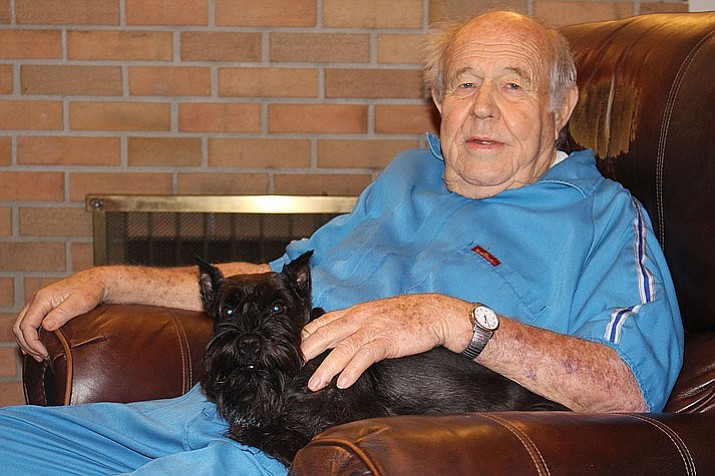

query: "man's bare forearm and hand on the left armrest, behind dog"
xmin=13 ymin=263 xmax=269 ymax=361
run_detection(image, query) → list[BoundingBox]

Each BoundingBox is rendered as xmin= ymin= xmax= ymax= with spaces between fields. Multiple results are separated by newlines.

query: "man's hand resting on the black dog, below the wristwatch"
xmin=302 ymin=294 xmax=472 ymax=390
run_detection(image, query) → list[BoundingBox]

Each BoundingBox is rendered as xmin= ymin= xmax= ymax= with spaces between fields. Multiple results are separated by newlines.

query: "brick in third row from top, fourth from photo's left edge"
xmin=219 ymin=68 xmax=318 ymax=98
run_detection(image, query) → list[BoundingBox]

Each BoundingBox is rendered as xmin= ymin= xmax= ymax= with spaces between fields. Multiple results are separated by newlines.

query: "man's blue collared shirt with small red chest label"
xmin=271 ymin=136 xmax=683 ymax=411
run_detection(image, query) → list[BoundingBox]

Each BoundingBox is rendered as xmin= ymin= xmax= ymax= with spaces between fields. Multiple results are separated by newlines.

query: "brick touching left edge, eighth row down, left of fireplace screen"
xmin=0 ymin=243 xmax=65 ymax=272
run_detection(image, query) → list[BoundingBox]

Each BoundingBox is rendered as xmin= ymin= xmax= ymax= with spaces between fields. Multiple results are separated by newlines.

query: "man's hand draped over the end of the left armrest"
xmin=12 ymin=268 xmax=105 ymax=362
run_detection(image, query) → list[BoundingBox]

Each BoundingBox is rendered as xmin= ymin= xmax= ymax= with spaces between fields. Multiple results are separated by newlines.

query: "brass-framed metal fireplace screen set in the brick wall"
xmin=86 ymin=195 xmax=355 ymax=266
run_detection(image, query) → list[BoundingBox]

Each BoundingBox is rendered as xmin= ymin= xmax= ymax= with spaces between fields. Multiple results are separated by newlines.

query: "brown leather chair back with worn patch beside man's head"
xmin=562 ymin=12 xmax=715 ymax=412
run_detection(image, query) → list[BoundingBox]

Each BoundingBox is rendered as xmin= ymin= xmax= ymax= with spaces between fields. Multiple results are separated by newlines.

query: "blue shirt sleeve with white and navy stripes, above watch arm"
xmin=572 ymin=193 xmax=683 ymax=412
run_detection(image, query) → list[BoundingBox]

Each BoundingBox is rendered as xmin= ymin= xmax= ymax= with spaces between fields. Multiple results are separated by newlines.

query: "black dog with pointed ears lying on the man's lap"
xmin=199 ymin=252 xmax=567 ymax=465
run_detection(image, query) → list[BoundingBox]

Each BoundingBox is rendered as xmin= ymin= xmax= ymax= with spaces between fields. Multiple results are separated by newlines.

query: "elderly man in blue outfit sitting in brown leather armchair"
xmin=0 ymin=12 xmax=683 ymax=474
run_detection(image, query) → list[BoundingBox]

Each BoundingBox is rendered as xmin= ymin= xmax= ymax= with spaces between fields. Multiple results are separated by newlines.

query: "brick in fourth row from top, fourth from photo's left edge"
xmin=268 ymin=104 xmax=367 ymax=134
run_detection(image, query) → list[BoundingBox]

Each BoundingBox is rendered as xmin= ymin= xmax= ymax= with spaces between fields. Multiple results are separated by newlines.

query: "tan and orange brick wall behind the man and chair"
xmin=0 ymin=0 xmax=687 ymax=406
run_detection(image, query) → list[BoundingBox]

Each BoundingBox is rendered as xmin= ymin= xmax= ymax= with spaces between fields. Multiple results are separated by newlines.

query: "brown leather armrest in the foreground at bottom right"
xmin=290 ymin=412 xmax=715 ymax=476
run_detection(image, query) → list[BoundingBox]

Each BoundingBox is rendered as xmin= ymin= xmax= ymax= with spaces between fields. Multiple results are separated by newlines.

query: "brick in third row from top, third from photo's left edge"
xmin=129 ymin=66 xmax=211 ymax=96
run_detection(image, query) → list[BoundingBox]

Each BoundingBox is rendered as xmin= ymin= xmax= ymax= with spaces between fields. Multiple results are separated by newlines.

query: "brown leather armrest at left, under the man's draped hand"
xmin=23 ymin=305 xmax=212 ymax=405
